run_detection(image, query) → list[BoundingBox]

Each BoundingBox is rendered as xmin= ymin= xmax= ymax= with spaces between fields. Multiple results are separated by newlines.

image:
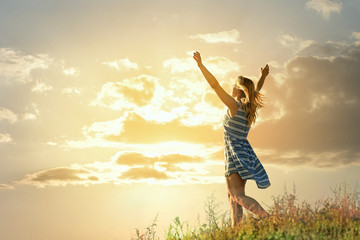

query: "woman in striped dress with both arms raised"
xmin=193 ymin=52 xmax=270 ymax=227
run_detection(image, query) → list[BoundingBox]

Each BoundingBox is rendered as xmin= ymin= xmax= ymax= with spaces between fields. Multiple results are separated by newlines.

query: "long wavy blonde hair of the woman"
xmin=235 ymin=76 xmax=264 ymax=126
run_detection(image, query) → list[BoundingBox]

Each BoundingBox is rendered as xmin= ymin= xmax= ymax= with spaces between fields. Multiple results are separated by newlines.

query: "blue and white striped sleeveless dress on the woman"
xmin=223 ymin=102 xmax=271 ymax=189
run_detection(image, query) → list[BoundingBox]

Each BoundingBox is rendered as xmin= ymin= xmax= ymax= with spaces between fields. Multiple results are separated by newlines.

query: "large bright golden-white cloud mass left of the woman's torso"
xmin=79 ymin=68 xmax=238 ymax=147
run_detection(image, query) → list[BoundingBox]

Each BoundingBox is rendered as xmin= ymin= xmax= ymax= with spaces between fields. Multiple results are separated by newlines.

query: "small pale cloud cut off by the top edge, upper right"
xmin=306 ymin=0 xmax=342 ymax=20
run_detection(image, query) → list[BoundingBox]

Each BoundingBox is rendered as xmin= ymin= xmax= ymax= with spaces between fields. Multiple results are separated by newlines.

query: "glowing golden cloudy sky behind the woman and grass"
xmin=0 ymin=0 xmax=360 ymax=240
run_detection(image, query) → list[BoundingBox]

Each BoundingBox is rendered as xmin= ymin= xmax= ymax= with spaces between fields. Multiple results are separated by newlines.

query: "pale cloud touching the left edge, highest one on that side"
xmin=0 ymin=48 xmax=53 ymax=83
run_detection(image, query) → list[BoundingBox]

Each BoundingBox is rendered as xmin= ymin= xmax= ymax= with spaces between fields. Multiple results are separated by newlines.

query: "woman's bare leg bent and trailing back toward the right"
xmin=226 ymin=173 xmax=269 ymax=218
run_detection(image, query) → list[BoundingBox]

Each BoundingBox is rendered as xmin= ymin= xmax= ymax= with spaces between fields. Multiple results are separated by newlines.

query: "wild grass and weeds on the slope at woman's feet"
xmin=132 ymin=183 xmax=360 ymax=240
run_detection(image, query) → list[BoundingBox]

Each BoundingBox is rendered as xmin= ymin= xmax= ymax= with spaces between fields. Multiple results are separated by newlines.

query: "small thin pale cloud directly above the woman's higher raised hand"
xmin=189 ymin=29 xmax=241 ymax=43
